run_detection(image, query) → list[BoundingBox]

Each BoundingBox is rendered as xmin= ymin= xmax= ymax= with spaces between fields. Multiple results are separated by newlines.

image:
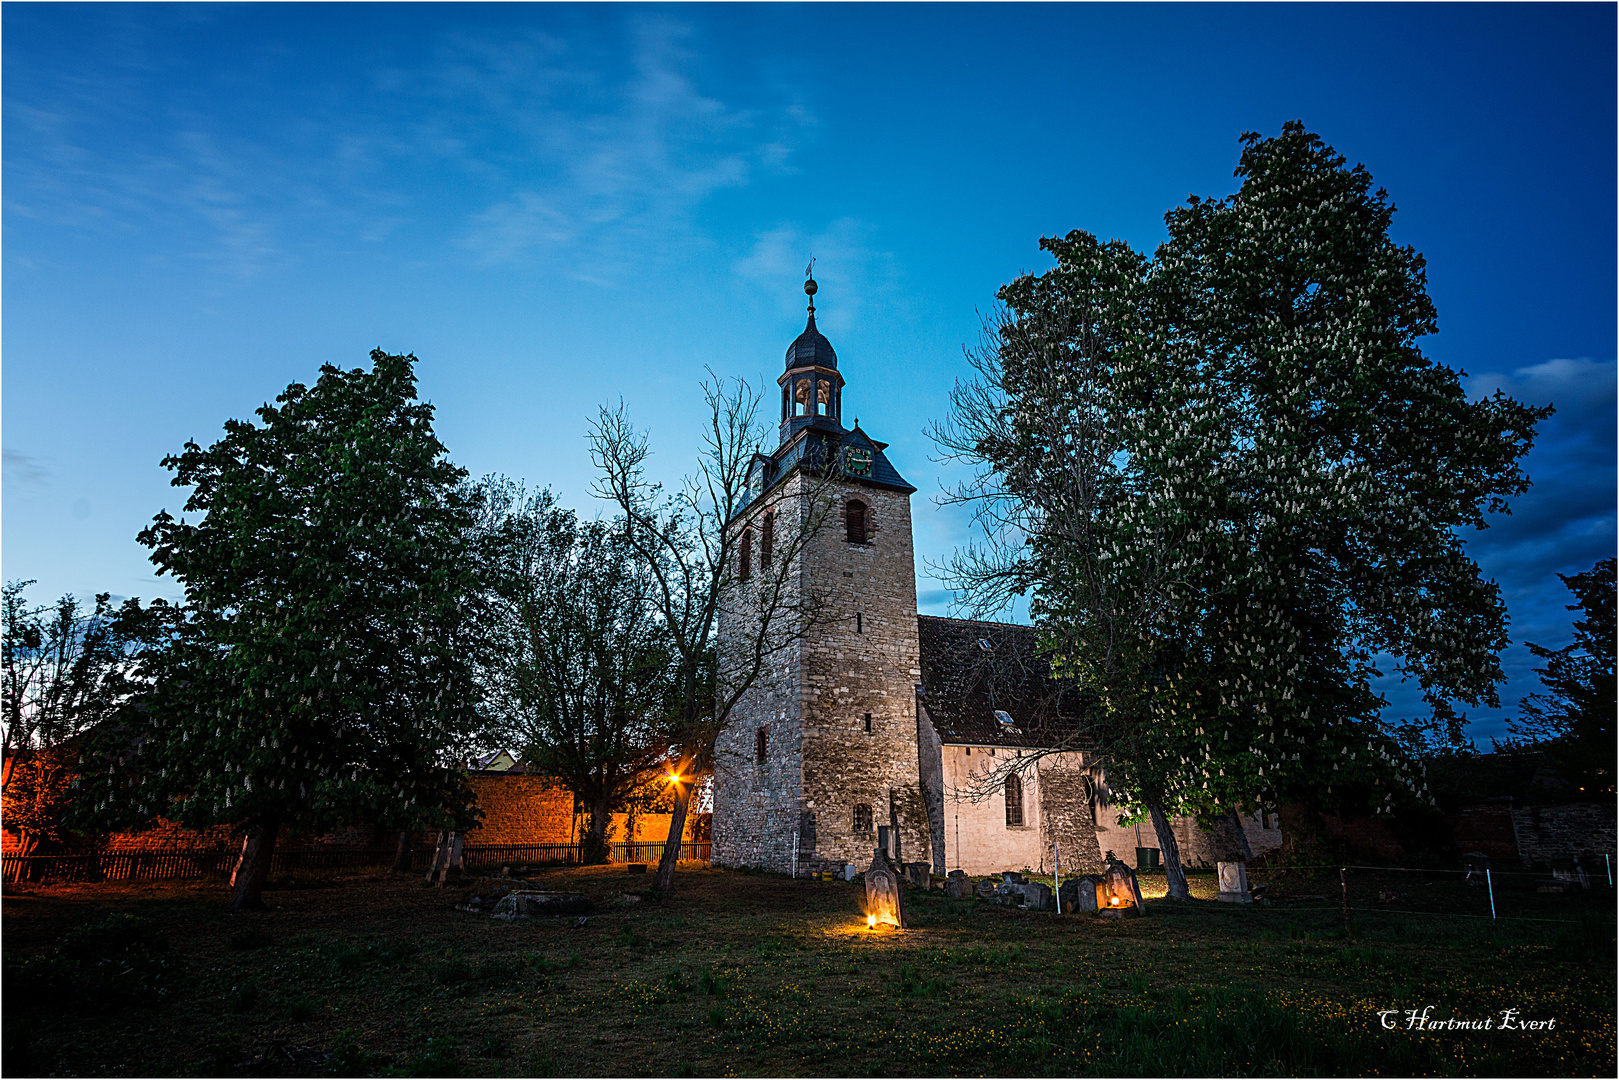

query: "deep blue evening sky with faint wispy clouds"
xmin=0 ymin=3 xmax=1616 ymax=735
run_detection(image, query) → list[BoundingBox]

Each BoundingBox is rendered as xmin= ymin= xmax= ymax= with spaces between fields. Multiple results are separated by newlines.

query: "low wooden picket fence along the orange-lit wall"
xmin=0 ymin=840 xmax=712 ymax=884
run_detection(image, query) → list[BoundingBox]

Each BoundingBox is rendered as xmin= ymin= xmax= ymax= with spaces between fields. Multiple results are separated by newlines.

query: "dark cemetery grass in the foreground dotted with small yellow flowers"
xmin=0 ymin=866 xmax=1616 ymax=1077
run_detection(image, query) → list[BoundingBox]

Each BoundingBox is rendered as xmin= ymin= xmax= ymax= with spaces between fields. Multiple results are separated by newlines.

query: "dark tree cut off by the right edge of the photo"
xmin=1502 ymin=559 xmax=1619 ymax=795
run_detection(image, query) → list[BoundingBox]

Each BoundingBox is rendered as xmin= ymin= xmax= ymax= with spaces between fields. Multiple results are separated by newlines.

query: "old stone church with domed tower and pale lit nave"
xmin=712 ymin=279 xmax=1281 ymax=874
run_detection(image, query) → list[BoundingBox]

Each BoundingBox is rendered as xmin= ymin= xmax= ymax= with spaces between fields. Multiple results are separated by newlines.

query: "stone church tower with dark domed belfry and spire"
xmin=714 ymin=279 xmax=933 ymax=873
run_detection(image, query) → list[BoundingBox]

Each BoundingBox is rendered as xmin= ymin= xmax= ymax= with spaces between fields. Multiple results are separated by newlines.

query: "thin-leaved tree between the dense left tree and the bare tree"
xmin=481 ymin=481 xmax=672 ymax=861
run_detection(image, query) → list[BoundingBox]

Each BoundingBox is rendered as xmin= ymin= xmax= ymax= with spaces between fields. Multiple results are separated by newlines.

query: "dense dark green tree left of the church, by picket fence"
xmin=81 ymin=350 xmax=478 ymax=910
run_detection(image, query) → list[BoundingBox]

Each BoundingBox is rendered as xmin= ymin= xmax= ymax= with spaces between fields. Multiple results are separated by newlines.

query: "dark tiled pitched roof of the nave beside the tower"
xmin=916 ymin=615 xmax=1085 ymax=748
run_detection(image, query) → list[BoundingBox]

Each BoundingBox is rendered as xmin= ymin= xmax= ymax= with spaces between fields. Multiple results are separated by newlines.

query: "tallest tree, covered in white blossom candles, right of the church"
xmin=937 ymin=121 xmax=1549 ymax=895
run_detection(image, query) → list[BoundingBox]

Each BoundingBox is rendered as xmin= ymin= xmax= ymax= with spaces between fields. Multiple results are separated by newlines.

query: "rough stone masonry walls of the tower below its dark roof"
xmin=714 ymin=474 xmax=931 ymax=871
